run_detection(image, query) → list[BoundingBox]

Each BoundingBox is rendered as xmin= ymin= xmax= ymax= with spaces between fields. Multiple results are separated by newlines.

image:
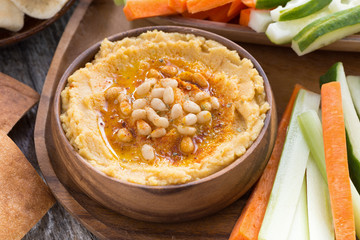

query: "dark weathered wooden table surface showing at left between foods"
xmin=0 ymin=2 xmax=97 ymax=240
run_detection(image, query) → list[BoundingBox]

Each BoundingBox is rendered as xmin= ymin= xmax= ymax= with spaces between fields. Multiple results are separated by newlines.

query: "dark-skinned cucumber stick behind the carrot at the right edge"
xmin=320 ymin=62 xmax=360 ymax=192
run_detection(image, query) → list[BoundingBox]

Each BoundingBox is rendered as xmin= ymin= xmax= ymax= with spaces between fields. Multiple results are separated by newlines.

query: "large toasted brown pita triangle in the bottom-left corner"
xmin=0 ymin=134 xmax=55 ymax=239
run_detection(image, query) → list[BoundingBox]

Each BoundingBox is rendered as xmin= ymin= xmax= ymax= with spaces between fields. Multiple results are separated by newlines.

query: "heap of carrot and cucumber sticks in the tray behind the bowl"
xmin=114 ymin=0 xmax=360 ymax=56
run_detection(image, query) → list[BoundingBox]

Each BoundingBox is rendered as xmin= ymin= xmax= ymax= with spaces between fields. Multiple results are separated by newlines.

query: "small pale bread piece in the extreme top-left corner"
xmin=0 ymin=0 xmax=24 ymax=32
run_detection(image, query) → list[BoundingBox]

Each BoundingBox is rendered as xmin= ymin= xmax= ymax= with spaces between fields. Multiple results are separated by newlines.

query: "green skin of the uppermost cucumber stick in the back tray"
xmin=279 ymin=0 xmax=332 ymax=21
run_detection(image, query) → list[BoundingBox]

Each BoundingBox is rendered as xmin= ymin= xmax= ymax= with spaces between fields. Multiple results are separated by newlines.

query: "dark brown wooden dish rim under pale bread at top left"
xmin=0 ymin=0 xmax=75 ymax=47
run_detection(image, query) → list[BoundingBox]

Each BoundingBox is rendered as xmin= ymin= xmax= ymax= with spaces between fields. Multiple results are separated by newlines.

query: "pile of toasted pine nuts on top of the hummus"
xmin=105 ymin=66 xmax=220 ymax=160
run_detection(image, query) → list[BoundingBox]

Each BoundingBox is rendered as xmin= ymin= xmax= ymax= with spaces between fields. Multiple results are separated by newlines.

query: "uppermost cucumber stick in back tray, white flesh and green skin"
xmin=271 ymin=0 xmax=331 ymax=21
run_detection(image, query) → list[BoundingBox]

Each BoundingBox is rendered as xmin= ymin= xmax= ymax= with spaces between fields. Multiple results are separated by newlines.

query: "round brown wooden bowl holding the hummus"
xmin=50 ymin=26 xmax=277 ymax=223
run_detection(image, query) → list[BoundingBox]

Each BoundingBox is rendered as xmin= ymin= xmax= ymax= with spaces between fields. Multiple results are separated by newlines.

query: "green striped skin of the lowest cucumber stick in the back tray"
xmin=293 ymin=6 xmax=360 ymax=52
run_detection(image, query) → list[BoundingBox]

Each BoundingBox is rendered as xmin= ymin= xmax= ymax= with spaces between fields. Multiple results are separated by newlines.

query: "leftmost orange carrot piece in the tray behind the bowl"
xmin=123 ymin=0 xmax=177 ymax=21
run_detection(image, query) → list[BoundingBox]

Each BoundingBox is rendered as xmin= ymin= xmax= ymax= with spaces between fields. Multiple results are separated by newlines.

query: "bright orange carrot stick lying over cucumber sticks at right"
xmin=321 ymin=82 xmax=355 ymax=240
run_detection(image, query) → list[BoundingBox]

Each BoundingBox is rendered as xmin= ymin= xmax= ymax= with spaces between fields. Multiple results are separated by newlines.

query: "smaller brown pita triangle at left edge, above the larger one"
xmin=0 ymin=73 xmax=40 ymax=133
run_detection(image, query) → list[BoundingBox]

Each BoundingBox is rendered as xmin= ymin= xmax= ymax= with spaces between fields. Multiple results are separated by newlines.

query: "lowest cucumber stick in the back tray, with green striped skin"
xmin=291 ymin=6 xmax=360 ymax=56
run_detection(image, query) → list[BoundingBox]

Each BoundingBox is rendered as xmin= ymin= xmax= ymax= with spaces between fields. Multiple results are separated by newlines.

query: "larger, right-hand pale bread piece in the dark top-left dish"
xmin=11 ymin=0 xmax=68 ymax=19
